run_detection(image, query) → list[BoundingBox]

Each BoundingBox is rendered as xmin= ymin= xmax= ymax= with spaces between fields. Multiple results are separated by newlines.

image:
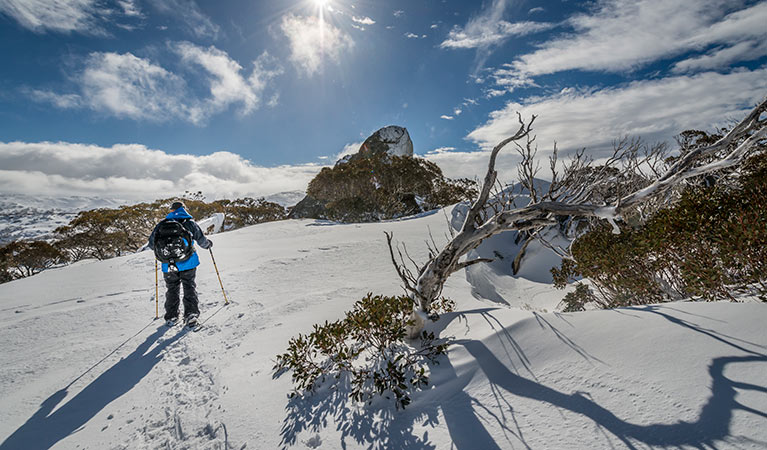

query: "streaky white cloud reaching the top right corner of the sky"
xmin=513 ymin=0 xmax=767 ymax=75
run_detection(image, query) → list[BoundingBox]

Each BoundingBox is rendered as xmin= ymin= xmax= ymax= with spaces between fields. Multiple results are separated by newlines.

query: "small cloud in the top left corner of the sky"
xmin=0 ymin=0 xmax=104 ymax=34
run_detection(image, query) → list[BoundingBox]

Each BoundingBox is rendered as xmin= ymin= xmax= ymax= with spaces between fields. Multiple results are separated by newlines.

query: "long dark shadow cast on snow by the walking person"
xmin=0 ymin=324 xmax=184 ymax=450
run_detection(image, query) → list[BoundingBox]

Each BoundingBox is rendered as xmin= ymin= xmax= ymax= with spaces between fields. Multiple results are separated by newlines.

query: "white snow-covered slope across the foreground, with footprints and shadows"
xmin=0 ymin=208 xmax=767 ymax=450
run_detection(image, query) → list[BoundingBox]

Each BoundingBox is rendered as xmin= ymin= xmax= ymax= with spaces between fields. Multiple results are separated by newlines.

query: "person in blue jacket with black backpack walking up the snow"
xmin=147 ymin=201 xmax=213 ymax=327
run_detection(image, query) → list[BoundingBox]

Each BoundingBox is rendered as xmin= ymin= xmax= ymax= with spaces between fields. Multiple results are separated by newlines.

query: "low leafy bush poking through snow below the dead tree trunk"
xmin=273 ymin=293 xmax=454 ymax=408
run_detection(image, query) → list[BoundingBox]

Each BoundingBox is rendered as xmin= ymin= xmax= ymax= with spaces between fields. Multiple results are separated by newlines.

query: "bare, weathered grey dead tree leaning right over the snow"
xmin=386 ymin=99 xmax=767 ymax=335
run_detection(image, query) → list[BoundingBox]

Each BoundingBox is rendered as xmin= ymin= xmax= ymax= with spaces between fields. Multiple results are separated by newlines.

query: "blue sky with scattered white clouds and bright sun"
xmin=0 ymin=0 xmax=767 ymax=200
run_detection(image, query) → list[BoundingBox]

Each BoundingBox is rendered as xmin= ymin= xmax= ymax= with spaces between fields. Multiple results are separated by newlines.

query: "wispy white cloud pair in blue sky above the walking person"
xmin=28 ymin=42 xmax=282 ymax=124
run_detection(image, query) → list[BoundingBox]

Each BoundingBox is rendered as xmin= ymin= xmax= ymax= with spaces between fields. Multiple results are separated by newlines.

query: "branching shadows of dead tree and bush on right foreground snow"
xmin=281 ymin=306 xmax=767 ymax=450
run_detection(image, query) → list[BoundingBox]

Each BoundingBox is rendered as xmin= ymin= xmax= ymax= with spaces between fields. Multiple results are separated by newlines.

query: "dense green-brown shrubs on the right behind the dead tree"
xmin=552 ymin=153 xmax=767 ymax=307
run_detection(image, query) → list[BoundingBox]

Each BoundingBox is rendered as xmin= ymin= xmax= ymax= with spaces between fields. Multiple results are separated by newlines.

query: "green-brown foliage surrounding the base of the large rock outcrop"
xmin=307 ymin=154 xmax=477 ymax=222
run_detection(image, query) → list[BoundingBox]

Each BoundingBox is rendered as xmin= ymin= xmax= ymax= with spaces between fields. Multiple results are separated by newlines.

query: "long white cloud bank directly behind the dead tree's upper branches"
xmin=468 ymin=68 xmax=767 ymax=159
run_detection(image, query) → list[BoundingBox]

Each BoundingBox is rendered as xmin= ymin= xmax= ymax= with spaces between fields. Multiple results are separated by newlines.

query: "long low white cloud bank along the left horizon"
xmin=0 ymin=142 xmax=322 ymax=201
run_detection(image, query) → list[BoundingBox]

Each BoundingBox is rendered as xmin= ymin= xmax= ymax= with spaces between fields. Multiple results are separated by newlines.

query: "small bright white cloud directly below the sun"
xmin=280 ymin=14 xmax=354 ymax=76
